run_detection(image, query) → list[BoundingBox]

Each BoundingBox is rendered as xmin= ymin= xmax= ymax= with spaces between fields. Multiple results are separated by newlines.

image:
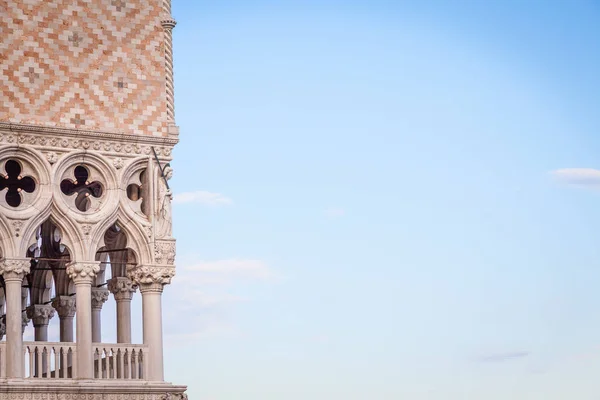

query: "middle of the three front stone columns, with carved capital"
xmin=67 ymin=261 xmax=100 ymax=379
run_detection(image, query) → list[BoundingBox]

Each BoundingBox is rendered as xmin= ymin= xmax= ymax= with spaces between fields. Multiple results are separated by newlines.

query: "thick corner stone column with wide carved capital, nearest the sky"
xmin=128 ymin=266 xmax=175 ymax=381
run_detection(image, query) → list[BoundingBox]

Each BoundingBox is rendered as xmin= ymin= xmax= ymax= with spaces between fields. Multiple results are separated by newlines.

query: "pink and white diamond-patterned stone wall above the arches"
xmin=0 ymin=0 xmax=174 ymax=137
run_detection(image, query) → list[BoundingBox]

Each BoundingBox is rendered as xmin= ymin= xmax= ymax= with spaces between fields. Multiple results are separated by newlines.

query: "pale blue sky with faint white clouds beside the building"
xmin=105 ymin=0 xmax=600 ymax=400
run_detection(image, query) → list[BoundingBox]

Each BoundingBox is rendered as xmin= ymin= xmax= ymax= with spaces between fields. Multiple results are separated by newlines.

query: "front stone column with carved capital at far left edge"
xmin=0 ymin=260 xmax=31 ymax=378
